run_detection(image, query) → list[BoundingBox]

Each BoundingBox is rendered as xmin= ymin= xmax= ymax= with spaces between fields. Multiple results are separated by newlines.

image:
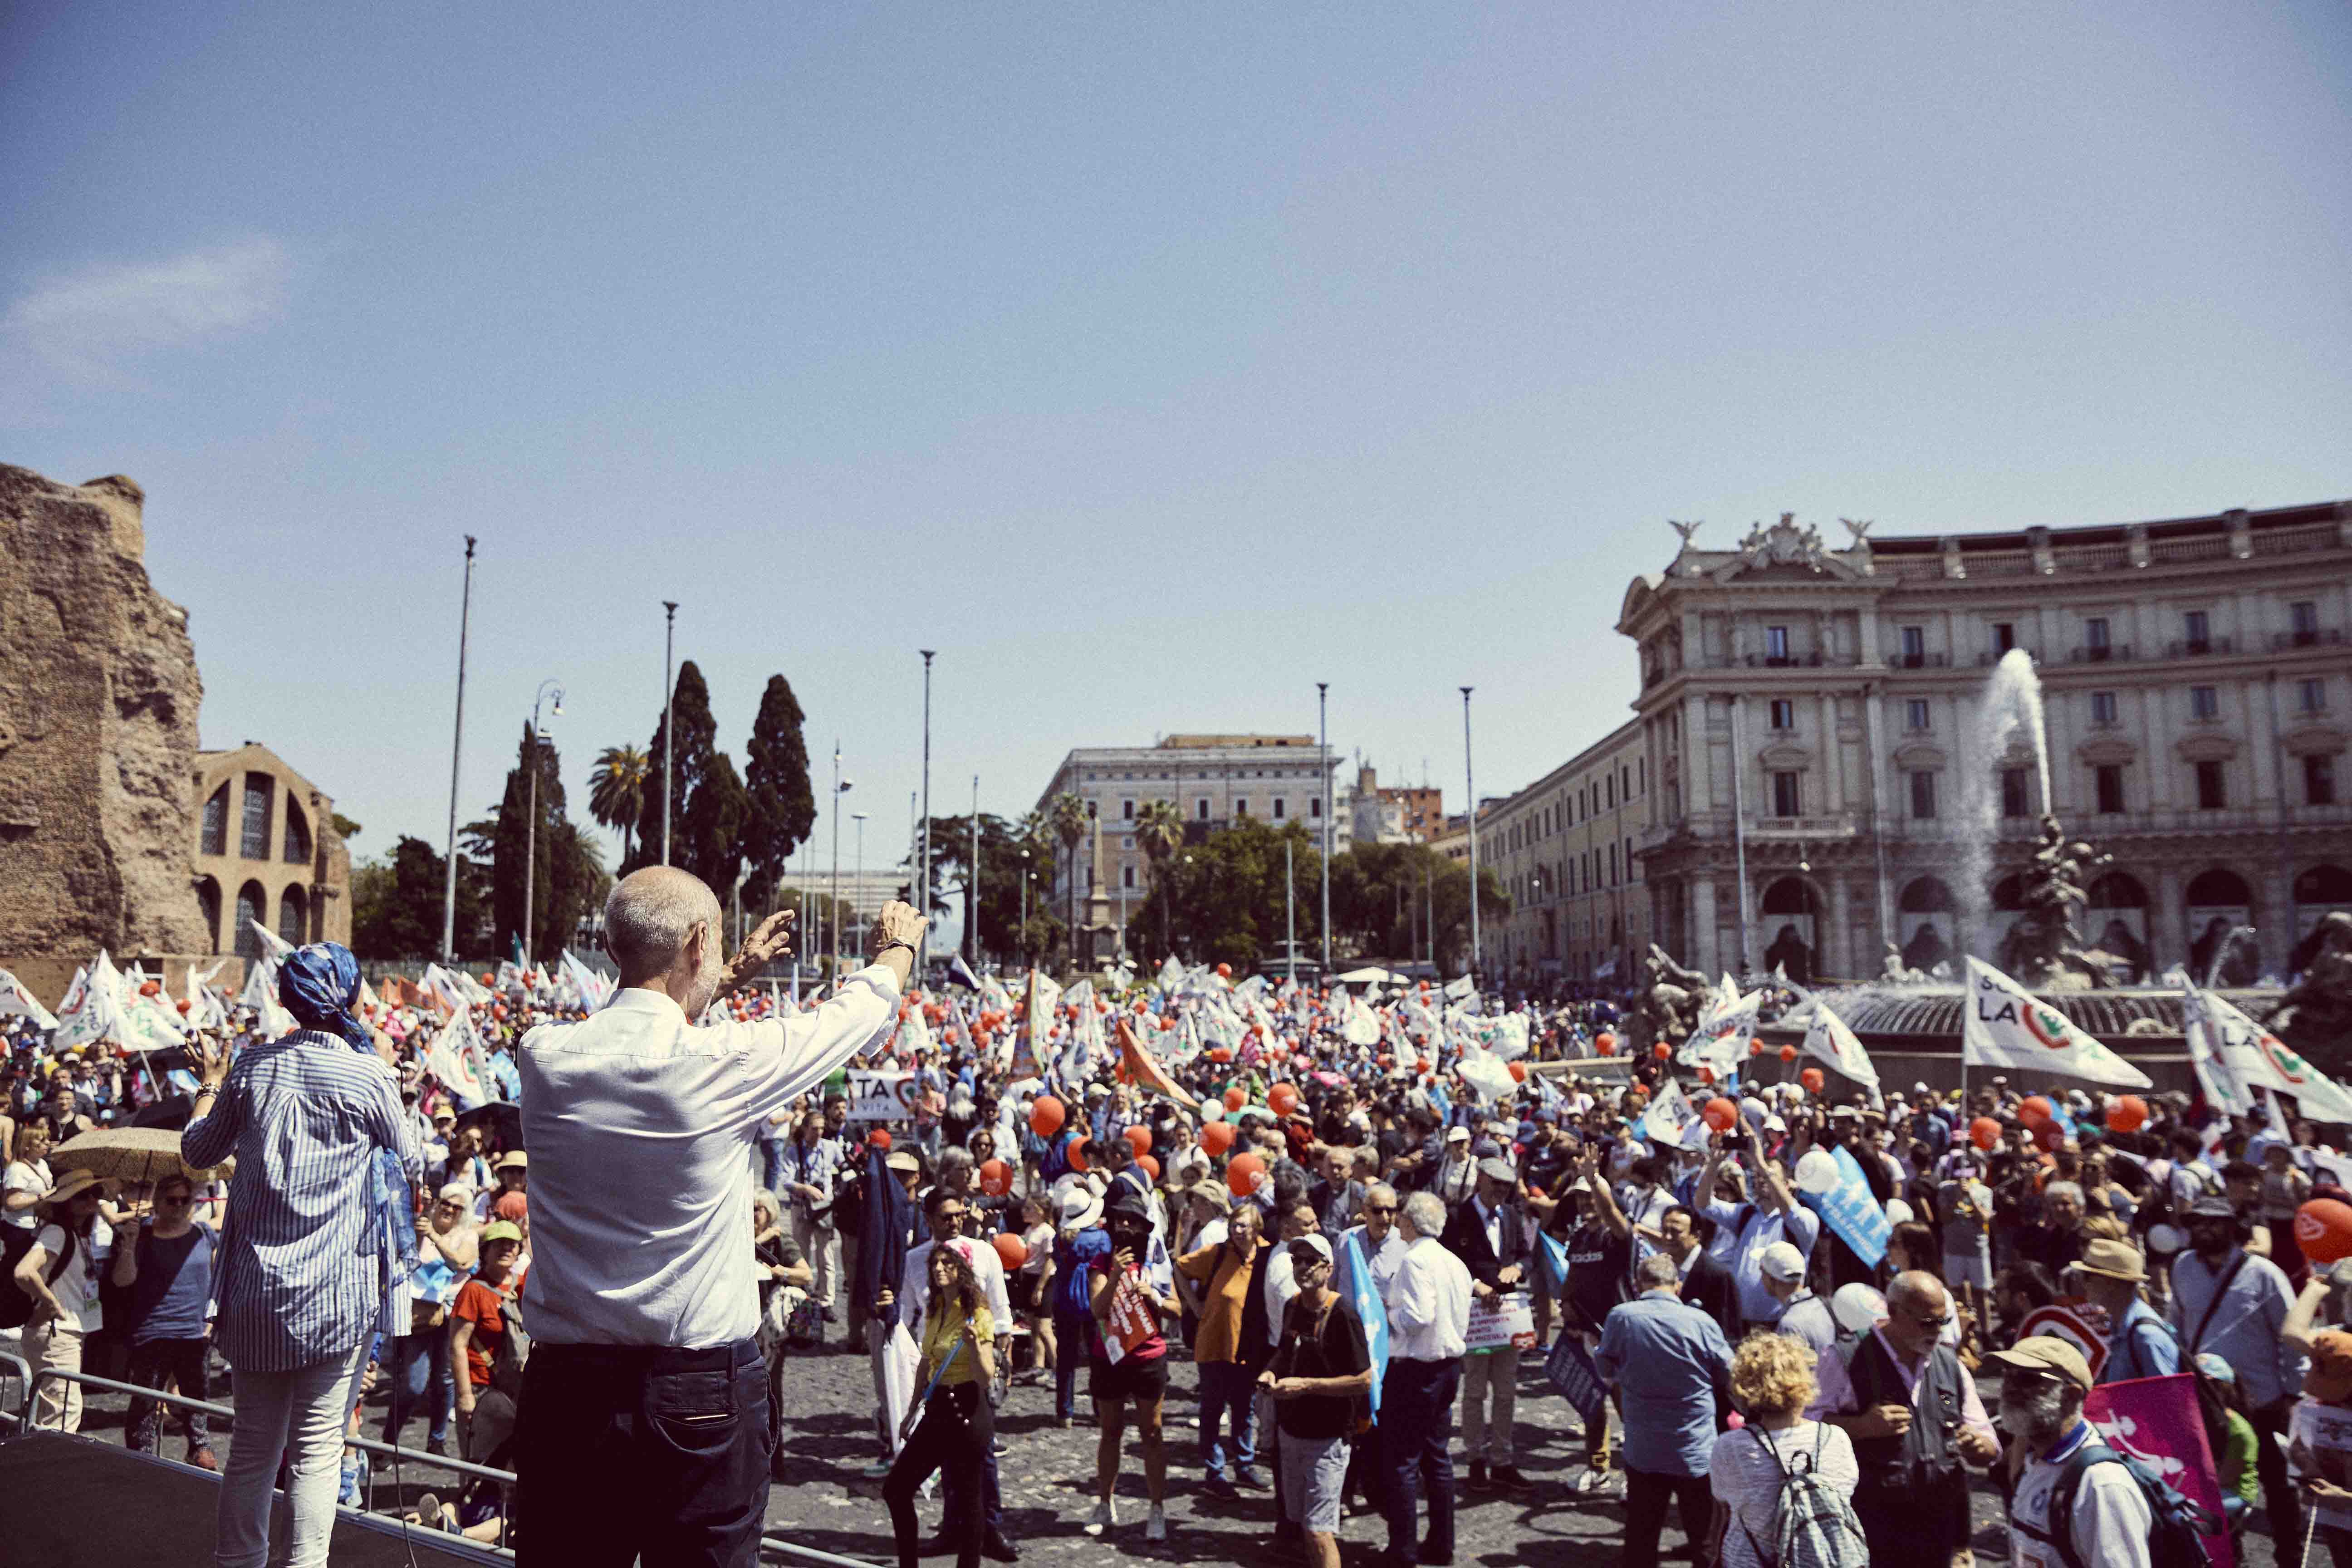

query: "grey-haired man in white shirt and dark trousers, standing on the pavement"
xmin=1381 ymin=1192 xmax=1470 ymax=1563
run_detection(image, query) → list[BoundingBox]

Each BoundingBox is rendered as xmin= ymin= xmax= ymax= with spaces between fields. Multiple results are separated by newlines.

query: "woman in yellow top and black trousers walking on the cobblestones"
xmin=882 ymin=1241 xmax=997 ymax=1568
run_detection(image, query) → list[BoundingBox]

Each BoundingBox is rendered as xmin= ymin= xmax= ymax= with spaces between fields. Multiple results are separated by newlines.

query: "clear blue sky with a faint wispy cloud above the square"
xmin=0 ymin=0 xmax=2352 ymax=921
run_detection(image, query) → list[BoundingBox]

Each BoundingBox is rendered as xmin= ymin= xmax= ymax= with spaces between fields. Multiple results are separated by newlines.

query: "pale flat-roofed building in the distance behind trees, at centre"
xmin=1035 ymin=736 xmax=1352 ymax=957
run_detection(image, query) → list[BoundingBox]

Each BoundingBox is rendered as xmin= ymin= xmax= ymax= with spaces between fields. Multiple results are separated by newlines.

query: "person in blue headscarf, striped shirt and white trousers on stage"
xmin=179 ymin=943 xmax=423 ymax=1568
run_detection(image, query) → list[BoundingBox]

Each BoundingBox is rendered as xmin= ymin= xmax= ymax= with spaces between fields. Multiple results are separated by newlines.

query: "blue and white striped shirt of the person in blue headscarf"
xmin=179 ymin=1029 xmax=423 ymax=1373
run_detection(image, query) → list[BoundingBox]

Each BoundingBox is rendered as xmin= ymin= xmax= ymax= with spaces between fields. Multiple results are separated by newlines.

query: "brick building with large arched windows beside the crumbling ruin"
xmin=193 ymin=740 xmax=350 ymax=959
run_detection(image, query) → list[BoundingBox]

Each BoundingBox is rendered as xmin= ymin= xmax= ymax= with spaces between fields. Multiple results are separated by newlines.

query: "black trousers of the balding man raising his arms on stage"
xmin=515 ymin=1340 xmax=774 ymax=1568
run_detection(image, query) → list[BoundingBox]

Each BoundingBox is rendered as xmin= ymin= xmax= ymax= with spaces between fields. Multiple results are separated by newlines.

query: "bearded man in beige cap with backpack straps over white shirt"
xmin=1987 ymin=1333 xmax=2155 ymax=1568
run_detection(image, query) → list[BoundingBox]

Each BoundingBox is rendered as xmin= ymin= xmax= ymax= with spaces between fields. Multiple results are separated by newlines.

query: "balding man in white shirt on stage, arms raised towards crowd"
xmin=515 ymin=865 xmax=926 ymax=1568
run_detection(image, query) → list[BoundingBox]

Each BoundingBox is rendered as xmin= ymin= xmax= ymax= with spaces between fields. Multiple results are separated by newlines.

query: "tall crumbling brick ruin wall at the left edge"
xmin=0 ymin=466 xmax=205 ymax=1004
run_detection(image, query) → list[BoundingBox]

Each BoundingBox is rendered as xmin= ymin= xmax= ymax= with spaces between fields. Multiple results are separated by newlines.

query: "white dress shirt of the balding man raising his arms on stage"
xmin=517 ymin=964 xmax=898 ymax=1349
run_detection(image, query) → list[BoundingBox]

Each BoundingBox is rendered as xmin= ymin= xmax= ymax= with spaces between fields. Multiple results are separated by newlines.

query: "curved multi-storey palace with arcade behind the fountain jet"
xmin=1618 ymin=501 xmax=2352 ymax=980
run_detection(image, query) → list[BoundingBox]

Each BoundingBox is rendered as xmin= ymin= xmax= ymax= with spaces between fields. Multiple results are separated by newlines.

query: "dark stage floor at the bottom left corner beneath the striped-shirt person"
xmin=0 ymin=1431 xmax=503 ymax=1568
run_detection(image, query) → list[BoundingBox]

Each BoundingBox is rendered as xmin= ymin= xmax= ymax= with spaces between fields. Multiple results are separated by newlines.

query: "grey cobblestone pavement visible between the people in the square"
xmin=37 ymin=1328 xmax=2274 ymax=1568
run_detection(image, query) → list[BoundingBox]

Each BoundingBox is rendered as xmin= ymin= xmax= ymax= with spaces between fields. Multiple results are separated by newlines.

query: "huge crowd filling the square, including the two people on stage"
xmin=14 ymin=870 xmax=2352 ymax=1568
